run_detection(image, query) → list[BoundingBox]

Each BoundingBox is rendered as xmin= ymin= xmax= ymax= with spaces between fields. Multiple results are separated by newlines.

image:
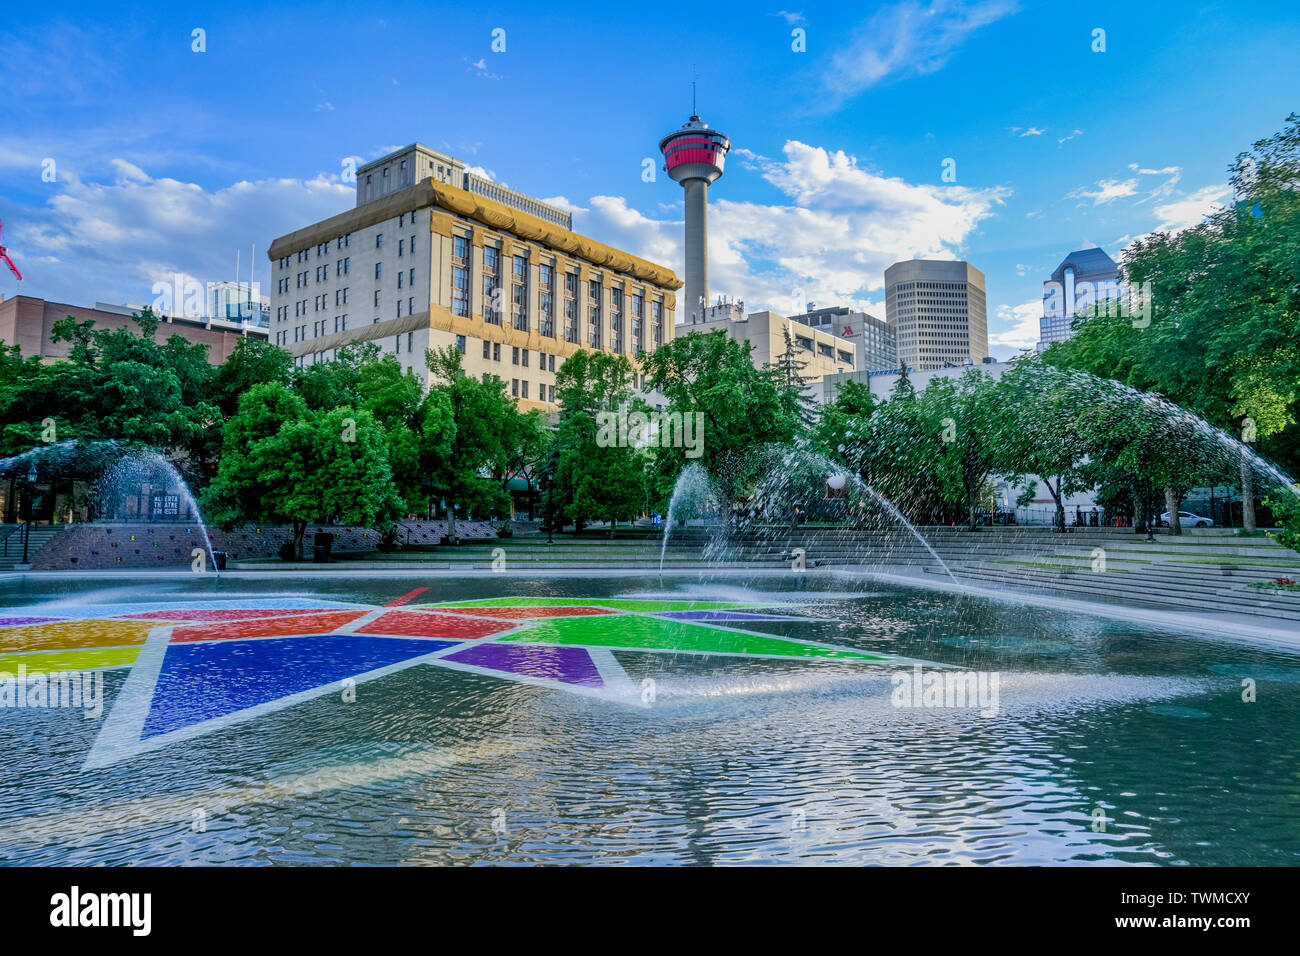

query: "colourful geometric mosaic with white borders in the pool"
xmin=0 ymin=588 xmax=900 ymax=767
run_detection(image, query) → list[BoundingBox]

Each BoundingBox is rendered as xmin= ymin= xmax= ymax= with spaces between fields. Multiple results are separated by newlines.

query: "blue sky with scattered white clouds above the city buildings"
xmin=0 ymin=0 xmax=1300 ymax=356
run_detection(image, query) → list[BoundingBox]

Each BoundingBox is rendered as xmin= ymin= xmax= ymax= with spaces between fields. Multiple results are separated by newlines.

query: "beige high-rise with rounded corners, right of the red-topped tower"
xmin=885 ymin=259 xmax=988 ymax=369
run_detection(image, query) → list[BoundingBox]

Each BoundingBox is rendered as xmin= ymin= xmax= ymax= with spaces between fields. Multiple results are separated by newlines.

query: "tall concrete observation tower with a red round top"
xmin=659 ymin=102 xmax=731 ymax=323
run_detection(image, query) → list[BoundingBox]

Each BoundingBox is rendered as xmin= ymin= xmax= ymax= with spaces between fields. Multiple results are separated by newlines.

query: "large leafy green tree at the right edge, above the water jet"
xmin=1044 ymin=113 xmax=1300 ymax=529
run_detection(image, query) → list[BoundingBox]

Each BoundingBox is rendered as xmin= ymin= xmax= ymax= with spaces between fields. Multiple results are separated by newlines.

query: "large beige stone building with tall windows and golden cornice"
xmin=268 ymin=143 xmax=681 ymax=411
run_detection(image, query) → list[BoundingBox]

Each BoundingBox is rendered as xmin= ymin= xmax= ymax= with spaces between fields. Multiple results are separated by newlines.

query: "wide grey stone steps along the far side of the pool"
xmin=340 ymin=527 xmax=1300 ymax=620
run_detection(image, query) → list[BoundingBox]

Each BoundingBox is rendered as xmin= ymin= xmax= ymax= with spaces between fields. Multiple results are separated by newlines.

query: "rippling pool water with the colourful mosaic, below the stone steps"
xmin=0 ymin=575 xmax=1300 ymax=865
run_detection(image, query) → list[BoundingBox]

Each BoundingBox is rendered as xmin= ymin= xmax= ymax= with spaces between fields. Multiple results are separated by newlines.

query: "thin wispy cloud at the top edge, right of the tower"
xmin=823 ymin=0 xmax=1019 ymax=107
